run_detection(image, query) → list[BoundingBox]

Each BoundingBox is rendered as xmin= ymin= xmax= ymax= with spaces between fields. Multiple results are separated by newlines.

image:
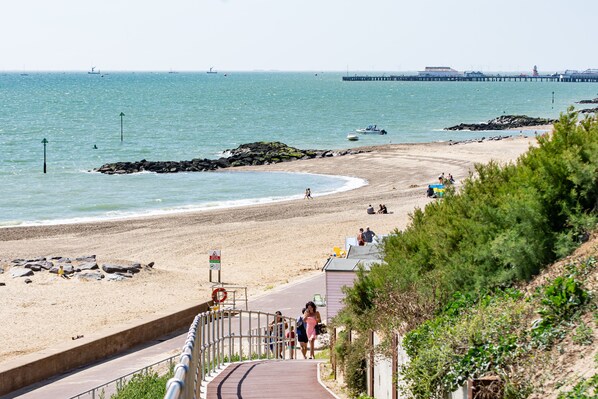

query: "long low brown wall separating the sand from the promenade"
xmin=0 ymin=302 xmax=211 ymax=395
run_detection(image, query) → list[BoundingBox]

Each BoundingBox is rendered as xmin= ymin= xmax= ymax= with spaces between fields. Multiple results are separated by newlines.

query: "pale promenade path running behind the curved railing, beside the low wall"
xmin=0 ymin=273 xmax=326 ymax=399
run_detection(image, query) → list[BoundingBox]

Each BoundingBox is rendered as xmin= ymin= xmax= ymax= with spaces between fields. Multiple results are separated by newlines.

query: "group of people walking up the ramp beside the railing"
xmin=268 ymin=301 xmax=322 ymax=359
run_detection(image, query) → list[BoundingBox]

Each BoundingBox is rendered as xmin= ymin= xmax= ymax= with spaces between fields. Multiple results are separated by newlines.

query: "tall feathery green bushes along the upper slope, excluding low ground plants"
xmin=346 ymin=111 xmax=598 ymax=330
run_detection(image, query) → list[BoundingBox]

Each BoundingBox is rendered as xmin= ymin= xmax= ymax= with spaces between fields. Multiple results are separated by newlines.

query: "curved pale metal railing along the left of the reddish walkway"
xmin=164 ymin=309 xmax=297 ymax=399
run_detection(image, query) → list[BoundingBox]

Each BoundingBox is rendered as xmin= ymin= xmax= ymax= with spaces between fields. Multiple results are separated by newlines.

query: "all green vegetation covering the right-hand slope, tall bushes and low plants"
xmin=335 ymin=110 xmax=598 ymax=399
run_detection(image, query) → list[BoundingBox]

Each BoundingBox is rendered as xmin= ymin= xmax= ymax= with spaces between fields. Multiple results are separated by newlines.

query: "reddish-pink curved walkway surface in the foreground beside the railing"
xmin=206 ymin=360 xmax=335 ymax=399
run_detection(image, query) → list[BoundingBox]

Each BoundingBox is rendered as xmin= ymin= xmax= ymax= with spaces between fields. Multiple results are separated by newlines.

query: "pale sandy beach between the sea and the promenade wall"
xmin=0 ymin=137 xmax=534 ymax=362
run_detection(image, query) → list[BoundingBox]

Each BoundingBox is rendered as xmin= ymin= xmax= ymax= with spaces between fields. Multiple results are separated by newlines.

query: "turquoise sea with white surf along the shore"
xmin=0 ymin=71 xmax=598 ymax=227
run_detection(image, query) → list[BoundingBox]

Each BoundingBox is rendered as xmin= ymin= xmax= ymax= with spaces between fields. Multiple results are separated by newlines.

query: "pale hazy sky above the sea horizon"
xmin=0 ymin=0 xmax=598 ymax=72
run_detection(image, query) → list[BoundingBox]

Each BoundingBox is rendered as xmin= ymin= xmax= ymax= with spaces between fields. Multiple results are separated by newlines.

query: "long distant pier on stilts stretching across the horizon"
xmin=343 ymin=75 xmax=598 ymax=83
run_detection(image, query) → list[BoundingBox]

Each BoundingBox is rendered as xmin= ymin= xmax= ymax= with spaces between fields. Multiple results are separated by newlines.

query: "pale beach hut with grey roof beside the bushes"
xmin=323 ymin=244 xmax=383 ymax=323
